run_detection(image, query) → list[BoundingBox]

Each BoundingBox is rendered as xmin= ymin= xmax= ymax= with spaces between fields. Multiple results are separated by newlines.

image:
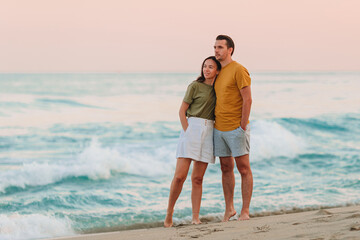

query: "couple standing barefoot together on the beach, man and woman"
xmin=164 ymin=35 xmax=253 ymax=227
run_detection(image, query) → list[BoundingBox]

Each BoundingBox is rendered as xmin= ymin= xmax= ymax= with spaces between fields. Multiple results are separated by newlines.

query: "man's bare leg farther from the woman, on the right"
xmin=235 ymin=154 xmax=253 ymax=220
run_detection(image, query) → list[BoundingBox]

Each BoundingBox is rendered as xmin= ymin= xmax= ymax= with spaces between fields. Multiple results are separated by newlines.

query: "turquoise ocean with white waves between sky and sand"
xmin=0 ymin=72 xmax=360 ymax=239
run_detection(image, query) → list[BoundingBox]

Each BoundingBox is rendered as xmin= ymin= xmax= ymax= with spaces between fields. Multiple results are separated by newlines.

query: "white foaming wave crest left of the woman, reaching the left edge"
xmin=0 ymin=139 xmax=175 ymax=192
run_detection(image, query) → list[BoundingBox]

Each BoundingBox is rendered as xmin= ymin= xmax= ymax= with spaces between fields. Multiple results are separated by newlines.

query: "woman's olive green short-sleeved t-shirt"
xmin=184 ymin=81 xmax=216 ymax=120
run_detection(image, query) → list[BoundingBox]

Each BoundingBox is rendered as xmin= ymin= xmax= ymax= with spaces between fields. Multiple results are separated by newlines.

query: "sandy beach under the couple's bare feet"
xmin=51 ymin=206 xmax=360 ymax=240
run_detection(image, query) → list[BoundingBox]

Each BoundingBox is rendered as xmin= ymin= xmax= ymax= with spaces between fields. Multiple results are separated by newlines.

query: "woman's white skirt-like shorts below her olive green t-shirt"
xmin=176 ymin=117 xmax=215 ymax=163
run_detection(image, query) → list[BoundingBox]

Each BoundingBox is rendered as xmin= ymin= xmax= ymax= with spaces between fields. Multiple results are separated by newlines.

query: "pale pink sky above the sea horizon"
xmin=0 ymin=0 xmax=360 ymax=72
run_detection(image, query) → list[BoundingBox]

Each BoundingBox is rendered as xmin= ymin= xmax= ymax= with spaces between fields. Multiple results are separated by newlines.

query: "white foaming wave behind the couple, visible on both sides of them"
xmin=0 ymin=121 xmax=306 ymax=192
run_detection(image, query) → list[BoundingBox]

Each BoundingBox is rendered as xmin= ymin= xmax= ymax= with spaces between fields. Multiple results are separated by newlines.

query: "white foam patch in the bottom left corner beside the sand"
xmin=0 ymin=213 xmax=75 ymax=240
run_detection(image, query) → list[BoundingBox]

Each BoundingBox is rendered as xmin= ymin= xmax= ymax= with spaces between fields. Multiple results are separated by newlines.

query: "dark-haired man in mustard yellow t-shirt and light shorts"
xmin=214 ymin=35 xmax=253 ymax=221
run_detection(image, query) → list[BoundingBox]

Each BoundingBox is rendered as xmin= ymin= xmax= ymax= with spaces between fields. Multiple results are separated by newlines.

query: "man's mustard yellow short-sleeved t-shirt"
xmin=215 ymin=61 xmax=251 ymax=131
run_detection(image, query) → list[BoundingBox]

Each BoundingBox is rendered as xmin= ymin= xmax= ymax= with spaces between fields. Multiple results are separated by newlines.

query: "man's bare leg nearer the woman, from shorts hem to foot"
xmin=220 ymin=157 xmax=236 ymax=222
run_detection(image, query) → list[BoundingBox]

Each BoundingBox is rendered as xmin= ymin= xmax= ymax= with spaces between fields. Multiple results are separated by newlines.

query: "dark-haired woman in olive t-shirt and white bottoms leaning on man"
xmin=164 ymin=56 xmax=221 ymax=227
